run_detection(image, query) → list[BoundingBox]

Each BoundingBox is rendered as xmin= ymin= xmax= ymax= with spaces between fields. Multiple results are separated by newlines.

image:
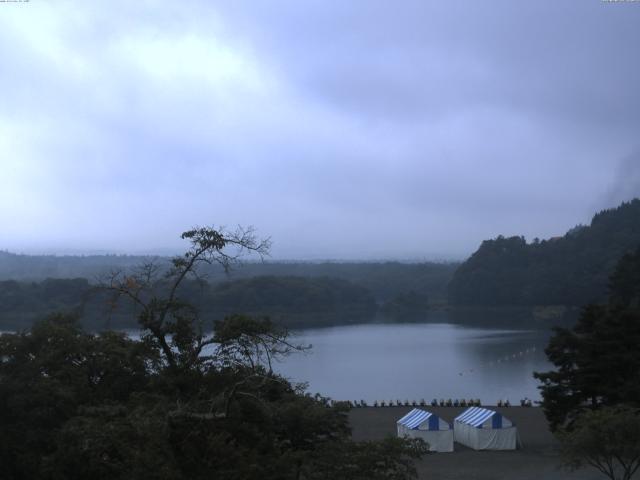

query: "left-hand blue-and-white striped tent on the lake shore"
xmin=396 ymin=408 xmax=453 ymax=452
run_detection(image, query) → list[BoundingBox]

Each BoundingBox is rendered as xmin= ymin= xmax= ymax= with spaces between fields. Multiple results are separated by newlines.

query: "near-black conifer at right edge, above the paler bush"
xmin=535 ymin=250 xmax=640 ymax=430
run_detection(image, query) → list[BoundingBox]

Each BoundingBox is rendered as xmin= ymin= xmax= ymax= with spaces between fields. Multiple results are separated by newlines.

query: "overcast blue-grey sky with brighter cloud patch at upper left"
xmin=0 ymin=0 xmax=640 ymax=259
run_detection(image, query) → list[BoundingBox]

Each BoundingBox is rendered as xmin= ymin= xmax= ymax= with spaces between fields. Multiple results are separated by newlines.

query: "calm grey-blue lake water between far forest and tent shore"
xmin=276 ymin=323 xmax=551 ymax=405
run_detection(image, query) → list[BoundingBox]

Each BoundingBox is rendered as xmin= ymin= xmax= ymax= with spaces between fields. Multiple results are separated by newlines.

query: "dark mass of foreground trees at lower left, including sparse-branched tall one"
xmin=0 ymin=228 xmax=426 ymax=480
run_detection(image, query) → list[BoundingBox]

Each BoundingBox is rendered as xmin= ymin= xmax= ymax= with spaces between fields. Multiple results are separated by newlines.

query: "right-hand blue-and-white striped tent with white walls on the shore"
xmin=454 ymin=407 xmax=518 ymax=450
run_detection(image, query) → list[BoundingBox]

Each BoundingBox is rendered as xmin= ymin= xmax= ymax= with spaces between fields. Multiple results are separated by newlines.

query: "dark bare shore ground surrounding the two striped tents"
xmin=349 ymin=407 xmax=604 ymax=480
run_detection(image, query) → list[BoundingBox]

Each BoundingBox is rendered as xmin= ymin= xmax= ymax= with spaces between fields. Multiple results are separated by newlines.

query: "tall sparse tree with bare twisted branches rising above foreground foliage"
xmin=102 ymin=227 xmax=270 ymax=370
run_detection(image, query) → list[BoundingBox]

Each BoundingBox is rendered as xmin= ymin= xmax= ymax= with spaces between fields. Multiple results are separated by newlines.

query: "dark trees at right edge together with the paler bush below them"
xmin=534 ymin=248 xmax=640 ymax=480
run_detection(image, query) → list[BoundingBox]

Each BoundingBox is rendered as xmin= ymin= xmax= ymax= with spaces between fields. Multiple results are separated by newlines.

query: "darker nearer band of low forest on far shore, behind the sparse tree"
xmin=0 ymin=276 xmax=378 ymax=331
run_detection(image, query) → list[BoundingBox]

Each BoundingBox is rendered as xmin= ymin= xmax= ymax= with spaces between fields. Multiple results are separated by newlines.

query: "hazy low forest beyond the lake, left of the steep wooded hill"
xmin=0 ymin=253 xmax=456 ymax=331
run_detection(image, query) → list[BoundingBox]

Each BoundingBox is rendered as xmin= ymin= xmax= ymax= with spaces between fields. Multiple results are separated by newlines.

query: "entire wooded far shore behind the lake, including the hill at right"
xmin=0 ymin=199 xmax=640 ymax=330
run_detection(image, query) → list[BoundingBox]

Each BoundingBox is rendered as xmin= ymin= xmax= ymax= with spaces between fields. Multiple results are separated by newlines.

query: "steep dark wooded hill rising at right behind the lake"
xmin=448 ymin=198 xmax=640 ymax=306
